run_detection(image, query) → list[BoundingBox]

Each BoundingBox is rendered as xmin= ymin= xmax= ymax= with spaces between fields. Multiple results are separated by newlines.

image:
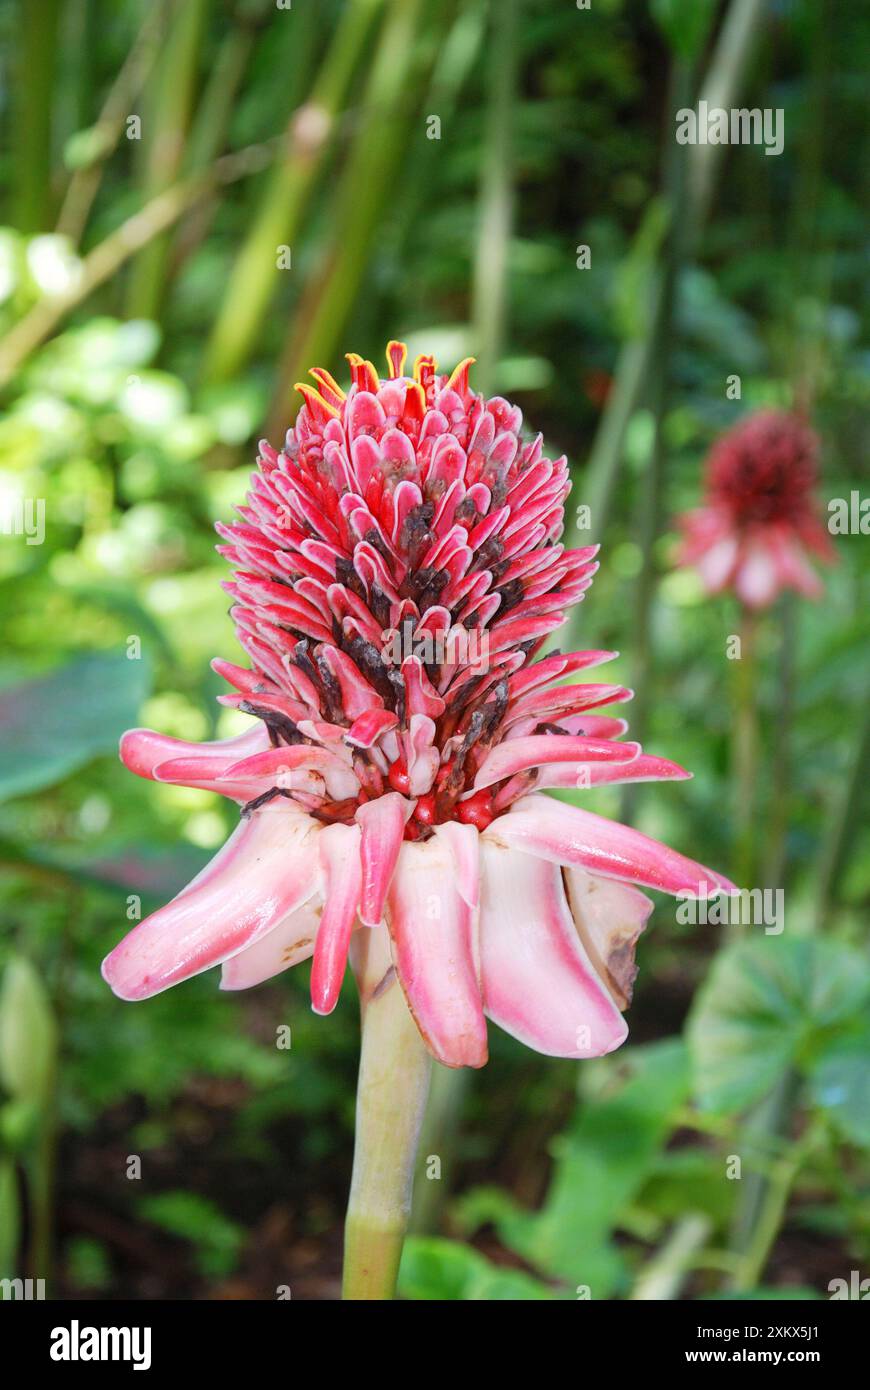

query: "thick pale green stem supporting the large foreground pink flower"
xmin=342 ymin=927 xmax=431 ymax=1300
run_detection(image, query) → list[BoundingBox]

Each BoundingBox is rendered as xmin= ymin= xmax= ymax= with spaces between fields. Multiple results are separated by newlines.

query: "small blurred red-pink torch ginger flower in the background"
xmin=680 ymin=410 xmax=834 ymax=609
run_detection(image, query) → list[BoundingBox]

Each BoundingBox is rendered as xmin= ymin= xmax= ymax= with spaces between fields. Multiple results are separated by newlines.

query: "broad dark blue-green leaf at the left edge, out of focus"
xmin=0 ymin=652 xmax=151 ymax=801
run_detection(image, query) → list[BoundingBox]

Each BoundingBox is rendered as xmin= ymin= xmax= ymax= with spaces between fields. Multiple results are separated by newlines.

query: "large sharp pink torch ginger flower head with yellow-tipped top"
xmin=103 ymin=342 xmax=728 ymax=1066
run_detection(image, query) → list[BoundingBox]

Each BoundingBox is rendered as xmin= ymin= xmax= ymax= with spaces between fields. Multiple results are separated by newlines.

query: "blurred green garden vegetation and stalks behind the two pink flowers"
xmin=0 ymin=0 xmax=870 ymax=1300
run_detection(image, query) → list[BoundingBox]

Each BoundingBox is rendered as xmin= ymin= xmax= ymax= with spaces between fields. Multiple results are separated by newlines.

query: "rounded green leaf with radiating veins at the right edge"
xmin=688 ymin=935 xmax=870 ymax=1112
